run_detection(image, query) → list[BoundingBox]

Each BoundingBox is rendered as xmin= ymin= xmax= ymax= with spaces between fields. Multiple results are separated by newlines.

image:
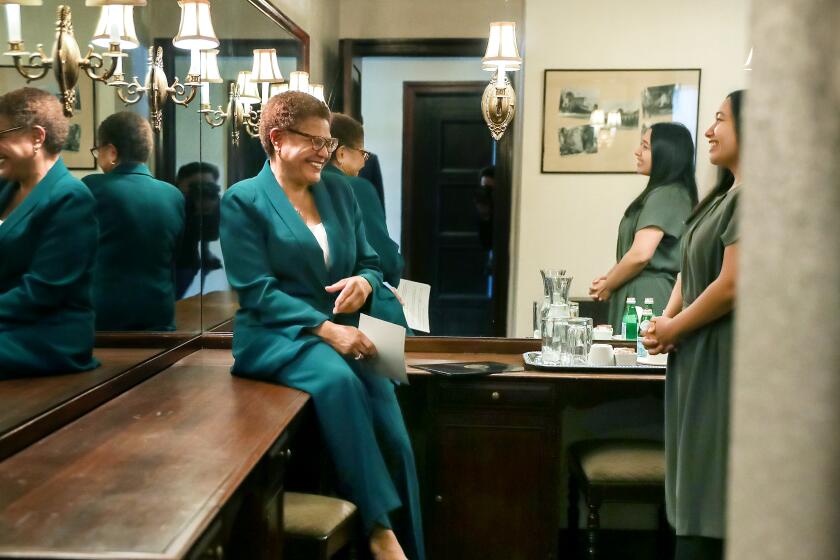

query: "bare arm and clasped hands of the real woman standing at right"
xmin=645 ymin=243 xmax=738 ymax=353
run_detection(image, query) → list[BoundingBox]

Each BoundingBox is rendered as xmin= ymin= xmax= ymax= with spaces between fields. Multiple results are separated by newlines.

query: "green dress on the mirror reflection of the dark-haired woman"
xmin=609 ymin=184 xmax=692 ymax=333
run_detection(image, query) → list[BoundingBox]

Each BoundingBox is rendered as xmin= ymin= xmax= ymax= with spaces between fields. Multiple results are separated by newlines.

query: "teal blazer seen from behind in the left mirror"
xmin=82 ymin=163 xmax=184 ymax=331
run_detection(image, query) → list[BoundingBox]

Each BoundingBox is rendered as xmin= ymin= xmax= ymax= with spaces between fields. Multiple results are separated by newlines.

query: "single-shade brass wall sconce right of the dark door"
xmin=481 ymin=21 xmax=522 ymax=141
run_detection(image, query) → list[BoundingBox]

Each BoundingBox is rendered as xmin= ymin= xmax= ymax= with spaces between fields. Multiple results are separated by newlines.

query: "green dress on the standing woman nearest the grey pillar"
xmin=665 ymin=187 xmax=740 ymax=539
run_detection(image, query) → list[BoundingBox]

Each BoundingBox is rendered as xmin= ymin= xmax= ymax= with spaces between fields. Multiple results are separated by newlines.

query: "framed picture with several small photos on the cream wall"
xmin=542 ymin=68 xmax=700 ymax=173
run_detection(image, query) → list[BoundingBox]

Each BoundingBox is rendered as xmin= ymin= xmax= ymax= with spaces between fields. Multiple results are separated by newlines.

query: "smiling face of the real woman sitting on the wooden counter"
xmin=276 ymin=117 xmax=330 ymax=185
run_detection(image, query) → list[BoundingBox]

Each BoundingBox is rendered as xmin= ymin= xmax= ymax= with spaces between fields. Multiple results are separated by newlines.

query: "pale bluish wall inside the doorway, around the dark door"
xmin=361 ymin=57 xmax=488 ymax=243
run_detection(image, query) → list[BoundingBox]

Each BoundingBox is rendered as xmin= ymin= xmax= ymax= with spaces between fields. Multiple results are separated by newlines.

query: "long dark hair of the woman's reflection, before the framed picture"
xmin=624 ymin=123 xmax=697 ymax=216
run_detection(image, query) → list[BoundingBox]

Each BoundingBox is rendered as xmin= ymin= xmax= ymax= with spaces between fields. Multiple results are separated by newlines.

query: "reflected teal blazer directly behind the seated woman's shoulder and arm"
xmin=324 ymin=164 xmax=405 ymax=288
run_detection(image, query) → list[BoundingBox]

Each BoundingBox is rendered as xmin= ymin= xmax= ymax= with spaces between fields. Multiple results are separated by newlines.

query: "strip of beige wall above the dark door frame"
xmin=339 ymin=0 xmax=525 ymax=38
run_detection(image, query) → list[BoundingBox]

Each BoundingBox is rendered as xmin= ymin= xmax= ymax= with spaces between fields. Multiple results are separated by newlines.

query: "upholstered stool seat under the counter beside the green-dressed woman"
xmin=571 ymin=440 xmax=665 ymax=484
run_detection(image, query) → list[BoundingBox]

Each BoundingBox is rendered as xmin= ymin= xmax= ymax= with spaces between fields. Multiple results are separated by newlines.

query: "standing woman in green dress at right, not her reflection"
xmin=645 ymin=91 xmax=744 ymax=560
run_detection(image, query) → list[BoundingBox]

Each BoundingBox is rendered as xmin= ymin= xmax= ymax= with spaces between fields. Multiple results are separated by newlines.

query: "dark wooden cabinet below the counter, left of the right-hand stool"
xmin=424 ymin=380 xmax=558 ymax=560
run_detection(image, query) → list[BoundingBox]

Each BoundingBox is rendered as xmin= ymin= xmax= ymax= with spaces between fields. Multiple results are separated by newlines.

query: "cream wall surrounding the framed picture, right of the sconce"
xmin=509 ymin=0 xmax=749 ymax=336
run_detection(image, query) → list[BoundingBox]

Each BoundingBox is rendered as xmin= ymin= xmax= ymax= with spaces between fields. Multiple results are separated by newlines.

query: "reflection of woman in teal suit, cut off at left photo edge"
xmin=0 ymin=88 xmax=97 ymax=378
